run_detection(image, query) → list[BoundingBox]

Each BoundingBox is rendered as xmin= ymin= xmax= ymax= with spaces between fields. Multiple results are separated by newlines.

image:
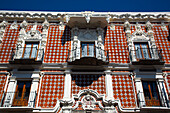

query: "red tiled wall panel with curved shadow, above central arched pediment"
xmin=72 ymin=75 xmax=106 ymax=94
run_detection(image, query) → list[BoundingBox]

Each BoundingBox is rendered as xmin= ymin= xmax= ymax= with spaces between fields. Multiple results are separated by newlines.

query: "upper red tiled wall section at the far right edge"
xmin=153 ymin=26 xmax=170 ymax=64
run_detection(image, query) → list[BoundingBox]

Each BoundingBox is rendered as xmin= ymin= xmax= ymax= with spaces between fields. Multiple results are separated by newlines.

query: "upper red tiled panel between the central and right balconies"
xmin=105 ymin=26 xmax=129 ymax=63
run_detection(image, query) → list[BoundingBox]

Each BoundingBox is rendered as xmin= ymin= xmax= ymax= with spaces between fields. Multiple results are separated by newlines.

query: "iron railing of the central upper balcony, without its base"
xmin=67 ymin=47 xmax=109 ymax=62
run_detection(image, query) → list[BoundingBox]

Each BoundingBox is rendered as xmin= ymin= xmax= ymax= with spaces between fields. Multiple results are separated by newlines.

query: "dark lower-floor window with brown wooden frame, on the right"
xmin=142 ymin=81 xmax=161 ymax=106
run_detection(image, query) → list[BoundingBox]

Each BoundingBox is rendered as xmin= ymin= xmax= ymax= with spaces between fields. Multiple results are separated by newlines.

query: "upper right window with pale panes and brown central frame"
xmin=134 ymin=43 xmax=151 ymax=60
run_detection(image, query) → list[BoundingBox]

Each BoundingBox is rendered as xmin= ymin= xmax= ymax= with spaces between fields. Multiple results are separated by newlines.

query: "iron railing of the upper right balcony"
xmin=129 ymin=48 xmax=163 ymax=62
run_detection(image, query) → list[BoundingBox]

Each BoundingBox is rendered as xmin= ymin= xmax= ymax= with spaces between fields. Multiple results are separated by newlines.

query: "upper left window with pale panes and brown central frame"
xmin=23 ymin=43 xmax=39 ymax=59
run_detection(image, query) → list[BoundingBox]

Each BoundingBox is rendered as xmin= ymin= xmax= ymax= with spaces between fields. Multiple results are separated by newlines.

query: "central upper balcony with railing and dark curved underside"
xmin=67 ymin=47 xmax=109 ymax=66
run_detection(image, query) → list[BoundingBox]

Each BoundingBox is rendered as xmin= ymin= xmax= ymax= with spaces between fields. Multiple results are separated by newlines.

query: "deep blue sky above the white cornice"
xmin=0 ymin=0 xmax=170 ymax=12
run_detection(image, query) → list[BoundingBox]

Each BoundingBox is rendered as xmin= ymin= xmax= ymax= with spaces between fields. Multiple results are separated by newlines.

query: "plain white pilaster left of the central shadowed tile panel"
xmin=63 ymin=70 xmax=71 ymax=100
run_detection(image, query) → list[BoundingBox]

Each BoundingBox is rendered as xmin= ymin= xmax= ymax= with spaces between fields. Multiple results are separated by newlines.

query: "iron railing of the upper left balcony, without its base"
xmin=10 ymin=47 xmax=44 ymax=61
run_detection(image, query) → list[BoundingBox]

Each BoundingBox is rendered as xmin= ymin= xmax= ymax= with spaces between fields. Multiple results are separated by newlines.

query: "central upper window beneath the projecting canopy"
xmin=81 ymin=42 xmax=95 ymax=57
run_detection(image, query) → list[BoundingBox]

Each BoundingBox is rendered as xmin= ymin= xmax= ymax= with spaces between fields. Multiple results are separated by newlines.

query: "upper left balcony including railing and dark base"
xmin=9 ymin=47 xmax=44 ymax=64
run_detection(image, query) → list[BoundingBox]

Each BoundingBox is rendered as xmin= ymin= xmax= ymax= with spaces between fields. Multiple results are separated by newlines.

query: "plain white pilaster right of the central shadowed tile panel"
xmin=105 ymin=70 xmax=114 ymax=100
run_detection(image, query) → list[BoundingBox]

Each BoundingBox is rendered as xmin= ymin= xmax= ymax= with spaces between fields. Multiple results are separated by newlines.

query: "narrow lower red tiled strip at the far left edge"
xmin=0 ymin=75 xmax=6 ymax=102
